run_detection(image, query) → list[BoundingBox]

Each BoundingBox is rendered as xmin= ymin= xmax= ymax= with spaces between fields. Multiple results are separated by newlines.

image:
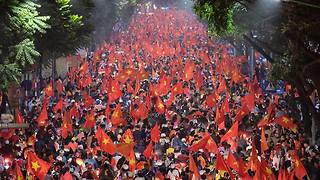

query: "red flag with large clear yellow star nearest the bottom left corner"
xmin=27 ymin=151 xmax=50 ymax=180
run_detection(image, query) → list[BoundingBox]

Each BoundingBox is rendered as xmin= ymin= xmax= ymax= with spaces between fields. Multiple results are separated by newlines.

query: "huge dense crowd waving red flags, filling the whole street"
xmin=0 ymin=3 xmax=320 ymax=180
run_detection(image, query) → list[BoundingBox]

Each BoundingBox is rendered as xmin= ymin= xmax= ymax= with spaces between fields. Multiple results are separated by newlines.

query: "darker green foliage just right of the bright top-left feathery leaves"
xmin=36 ymin=0 xmax=92 ymax=58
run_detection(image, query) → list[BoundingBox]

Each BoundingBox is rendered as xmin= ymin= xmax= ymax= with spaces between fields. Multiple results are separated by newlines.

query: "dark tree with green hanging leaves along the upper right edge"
xmin=194 ymin=0 xmax=320 ymax=143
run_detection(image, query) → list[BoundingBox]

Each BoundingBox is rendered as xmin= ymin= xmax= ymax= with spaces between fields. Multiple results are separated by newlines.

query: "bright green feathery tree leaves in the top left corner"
xmin=0 ymin=0 xmax=50 ymax=92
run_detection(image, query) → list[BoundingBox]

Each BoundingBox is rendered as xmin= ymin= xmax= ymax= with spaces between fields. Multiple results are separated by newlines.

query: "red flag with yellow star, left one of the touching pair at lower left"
xmin=96 ymin=126 xmax=116 ymax=155
